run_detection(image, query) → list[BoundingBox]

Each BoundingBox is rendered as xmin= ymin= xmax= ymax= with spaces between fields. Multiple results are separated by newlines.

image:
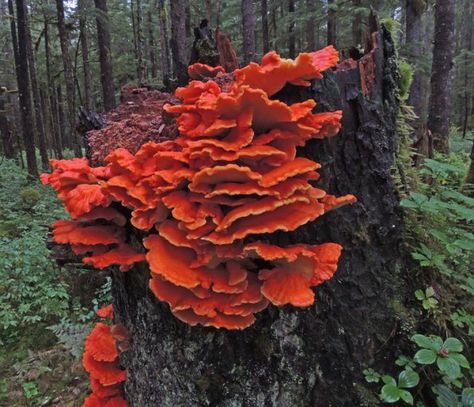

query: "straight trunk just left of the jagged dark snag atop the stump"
xmin=170 ymin=0 xmax=188 ymax=86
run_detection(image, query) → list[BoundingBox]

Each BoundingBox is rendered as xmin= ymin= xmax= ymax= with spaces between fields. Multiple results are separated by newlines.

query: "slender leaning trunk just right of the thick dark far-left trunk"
xmin=25 ymin=4 xmax=49 ymax=168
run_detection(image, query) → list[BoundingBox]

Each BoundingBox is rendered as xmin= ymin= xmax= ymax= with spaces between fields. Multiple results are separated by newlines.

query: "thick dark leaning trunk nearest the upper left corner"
xmin=8 ymin=0 xmax=38 ymax=178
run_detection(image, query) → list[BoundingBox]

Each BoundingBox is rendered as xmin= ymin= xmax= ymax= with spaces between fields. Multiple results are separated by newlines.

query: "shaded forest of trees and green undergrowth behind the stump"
xmin=0 ymin=0 xmax=474 ymax=407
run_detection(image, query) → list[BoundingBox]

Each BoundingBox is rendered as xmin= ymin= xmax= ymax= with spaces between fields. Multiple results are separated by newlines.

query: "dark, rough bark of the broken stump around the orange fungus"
xmin=98 ymin=26 xmax=405 ymax=407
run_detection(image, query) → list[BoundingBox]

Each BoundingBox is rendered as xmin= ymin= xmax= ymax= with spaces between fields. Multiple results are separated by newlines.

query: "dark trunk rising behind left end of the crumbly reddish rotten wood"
xmin=94 ymin=0 xmax=115 ymax=112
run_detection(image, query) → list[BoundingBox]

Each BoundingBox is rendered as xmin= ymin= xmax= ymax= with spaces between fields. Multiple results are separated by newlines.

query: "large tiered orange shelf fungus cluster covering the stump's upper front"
xmin=42 ymin=46 xmax=355 ymax=329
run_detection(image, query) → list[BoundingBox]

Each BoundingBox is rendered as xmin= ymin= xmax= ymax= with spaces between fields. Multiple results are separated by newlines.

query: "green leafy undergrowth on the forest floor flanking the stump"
xmin=0 ymin=133 xmax=474 ymax=407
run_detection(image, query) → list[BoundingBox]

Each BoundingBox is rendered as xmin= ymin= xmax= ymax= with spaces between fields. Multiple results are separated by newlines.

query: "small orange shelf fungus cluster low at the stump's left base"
xmin=82 ymin=305 xmax=130 ymax=407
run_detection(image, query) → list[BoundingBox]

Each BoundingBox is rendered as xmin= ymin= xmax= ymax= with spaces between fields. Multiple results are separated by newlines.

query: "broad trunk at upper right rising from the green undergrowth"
xmin=428 ymin=0 xmax=455 ymax=153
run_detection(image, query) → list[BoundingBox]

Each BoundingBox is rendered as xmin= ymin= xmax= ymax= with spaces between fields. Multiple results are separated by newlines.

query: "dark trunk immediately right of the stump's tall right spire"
xmin=404 ymin=0 xmax=427 ymax=128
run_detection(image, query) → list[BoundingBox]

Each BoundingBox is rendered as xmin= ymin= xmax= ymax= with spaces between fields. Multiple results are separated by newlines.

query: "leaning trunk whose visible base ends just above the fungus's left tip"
xmin=56 ymin=0 xmax=82 ymax=157
